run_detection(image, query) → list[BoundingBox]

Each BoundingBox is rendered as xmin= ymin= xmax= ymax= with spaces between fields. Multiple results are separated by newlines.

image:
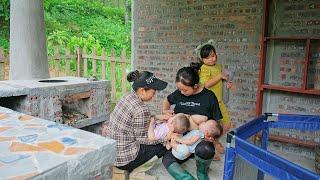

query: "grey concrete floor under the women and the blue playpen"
xmin=148 ymin=136 xmax=315 ymax=180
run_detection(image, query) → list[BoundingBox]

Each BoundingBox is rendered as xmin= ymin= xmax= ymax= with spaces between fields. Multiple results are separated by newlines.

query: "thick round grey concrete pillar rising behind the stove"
xmin=9 ymin=0 xmax=49 ymax=80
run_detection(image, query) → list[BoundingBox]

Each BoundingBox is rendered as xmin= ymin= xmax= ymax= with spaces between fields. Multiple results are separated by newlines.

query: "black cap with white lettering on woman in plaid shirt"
xmin=132 ymin=71 xmax=168 ymax=90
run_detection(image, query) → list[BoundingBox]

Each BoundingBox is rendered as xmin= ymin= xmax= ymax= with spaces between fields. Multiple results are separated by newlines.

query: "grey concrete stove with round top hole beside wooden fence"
xmin=0 ymin=77 xmax=110 ymax=128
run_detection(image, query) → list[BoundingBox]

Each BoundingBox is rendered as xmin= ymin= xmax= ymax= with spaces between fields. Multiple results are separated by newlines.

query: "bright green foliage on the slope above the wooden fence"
xmin=0 ymin=0 xmax=131 ymax=55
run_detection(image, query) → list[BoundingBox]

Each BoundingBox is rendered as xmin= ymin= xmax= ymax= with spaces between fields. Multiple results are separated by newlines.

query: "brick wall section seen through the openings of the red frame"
xmin=264 ymin=0 xmax=320 ymax=116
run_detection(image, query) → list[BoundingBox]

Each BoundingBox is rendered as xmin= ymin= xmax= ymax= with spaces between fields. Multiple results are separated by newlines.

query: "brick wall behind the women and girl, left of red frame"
xmin=133 ymin=0 xmax=262 ymax=126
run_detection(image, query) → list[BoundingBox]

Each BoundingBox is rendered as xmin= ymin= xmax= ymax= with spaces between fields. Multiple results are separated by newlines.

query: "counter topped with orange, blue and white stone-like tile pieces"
xmin=0 ymin=107 xmax=115 ymax=179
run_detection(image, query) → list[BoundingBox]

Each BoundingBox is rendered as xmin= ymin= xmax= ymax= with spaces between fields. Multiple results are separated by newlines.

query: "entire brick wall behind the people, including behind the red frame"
xmin=132 ymin=0 xmax=320 ymax=125
